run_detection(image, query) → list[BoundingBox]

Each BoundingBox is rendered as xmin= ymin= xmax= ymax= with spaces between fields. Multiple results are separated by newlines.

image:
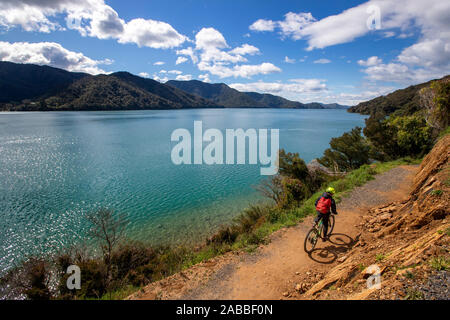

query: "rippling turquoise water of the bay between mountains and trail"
xmin=0 ymin=109 xmax=364 ymax=270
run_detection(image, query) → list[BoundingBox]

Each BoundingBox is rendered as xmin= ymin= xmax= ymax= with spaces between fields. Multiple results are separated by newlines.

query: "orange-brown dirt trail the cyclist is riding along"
xmin=130 ymin=166 xmax=417 ymax=300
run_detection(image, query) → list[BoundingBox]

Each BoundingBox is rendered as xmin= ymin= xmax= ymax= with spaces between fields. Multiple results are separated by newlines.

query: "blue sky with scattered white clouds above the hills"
xmin=0 ymin=0 xmax=450 ymax=105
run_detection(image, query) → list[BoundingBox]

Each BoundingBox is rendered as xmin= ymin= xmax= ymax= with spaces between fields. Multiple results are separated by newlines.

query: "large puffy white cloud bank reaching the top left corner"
xmin=0 ymin=0 xmax=187 ymax=49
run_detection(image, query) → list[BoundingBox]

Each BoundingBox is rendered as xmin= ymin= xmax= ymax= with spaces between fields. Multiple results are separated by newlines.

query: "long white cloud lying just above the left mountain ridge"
xmin=0 ymin=41 xmax=111 ymax=74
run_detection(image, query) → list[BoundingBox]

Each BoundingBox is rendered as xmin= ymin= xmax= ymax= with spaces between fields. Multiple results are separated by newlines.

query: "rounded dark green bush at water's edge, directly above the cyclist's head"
xmin=319 ymin=127 xmax=370 ymax=171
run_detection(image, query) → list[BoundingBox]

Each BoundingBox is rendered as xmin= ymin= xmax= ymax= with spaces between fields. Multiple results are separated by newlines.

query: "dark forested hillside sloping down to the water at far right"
xmin=348 ymin=75 xmax=450 ymax=115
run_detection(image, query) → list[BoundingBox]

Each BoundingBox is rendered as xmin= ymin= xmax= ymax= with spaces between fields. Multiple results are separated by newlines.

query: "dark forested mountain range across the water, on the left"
xmin=0 ymin=62 xmax=347 ymax=111
